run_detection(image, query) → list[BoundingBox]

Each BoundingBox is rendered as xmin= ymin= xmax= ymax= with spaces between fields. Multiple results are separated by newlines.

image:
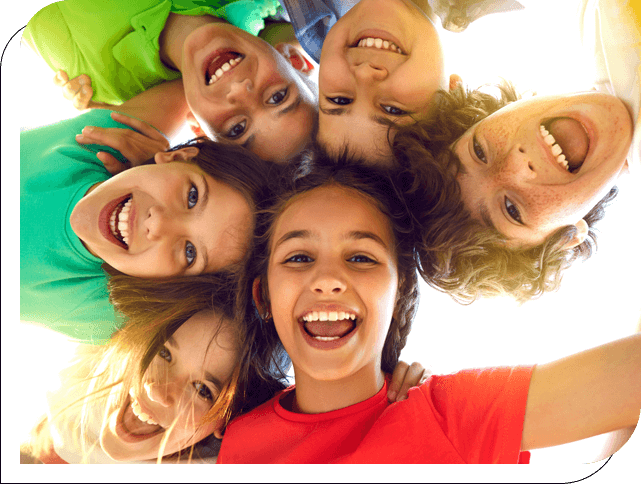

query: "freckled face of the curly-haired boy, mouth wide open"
xmin=454 ymin=92 xmax=632 ymax=246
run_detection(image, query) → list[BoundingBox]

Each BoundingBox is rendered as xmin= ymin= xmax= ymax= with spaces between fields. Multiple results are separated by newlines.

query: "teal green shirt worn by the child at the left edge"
xmin=20 ymin=109 xmax=139 ymax=344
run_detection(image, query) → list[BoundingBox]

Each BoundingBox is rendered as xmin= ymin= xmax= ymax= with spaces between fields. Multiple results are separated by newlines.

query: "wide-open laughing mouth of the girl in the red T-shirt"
xmin=298 ymin=311 xmax=360 ymax=349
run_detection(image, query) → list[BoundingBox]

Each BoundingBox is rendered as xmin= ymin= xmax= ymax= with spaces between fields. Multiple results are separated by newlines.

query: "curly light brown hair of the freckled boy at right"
xmin=393 ymin=81 xmax=617 ymax=304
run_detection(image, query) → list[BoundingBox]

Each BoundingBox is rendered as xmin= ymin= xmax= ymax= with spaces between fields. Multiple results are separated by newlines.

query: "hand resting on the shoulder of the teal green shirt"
xmin=76 ymin=112 xmax=169 ymax=175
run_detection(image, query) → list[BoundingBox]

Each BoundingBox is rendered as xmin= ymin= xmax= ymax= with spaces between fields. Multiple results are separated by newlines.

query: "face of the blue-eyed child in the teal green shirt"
xmin=70 ymin=148 xmax=253 ymax=278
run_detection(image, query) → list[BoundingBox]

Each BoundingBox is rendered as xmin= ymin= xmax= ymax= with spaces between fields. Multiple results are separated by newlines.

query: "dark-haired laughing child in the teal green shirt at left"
xmin=20 ymin=110 xmax=277 ymax=343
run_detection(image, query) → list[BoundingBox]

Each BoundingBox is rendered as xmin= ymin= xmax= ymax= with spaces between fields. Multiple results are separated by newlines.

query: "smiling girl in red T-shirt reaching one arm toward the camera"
xmin=218 ymin=153 xmax=641 ymax=463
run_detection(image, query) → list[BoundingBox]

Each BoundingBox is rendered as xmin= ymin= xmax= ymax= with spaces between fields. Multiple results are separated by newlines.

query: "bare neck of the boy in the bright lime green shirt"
xmin=158 ymin=13 xmax=227 ymax=71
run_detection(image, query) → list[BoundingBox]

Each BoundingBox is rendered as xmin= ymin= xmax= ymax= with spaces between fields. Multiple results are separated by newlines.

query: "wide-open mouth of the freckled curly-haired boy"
xmin=539 ymin=117 xmax=590 ymax=174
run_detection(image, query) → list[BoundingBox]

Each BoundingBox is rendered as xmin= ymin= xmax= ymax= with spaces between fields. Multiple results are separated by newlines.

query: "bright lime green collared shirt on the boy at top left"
xmin=22 ymin=0 xmax=283 ymax=104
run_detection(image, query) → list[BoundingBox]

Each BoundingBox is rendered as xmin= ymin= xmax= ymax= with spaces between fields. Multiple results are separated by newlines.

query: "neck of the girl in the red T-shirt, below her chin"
xmin=283 ymin=361 xmax=385 ymax=413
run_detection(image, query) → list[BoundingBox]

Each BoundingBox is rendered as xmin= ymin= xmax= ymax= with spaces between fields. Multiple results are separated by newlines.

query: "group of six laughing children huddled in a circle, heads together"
xmin=20 ymin=0 xmax=641 ymax=463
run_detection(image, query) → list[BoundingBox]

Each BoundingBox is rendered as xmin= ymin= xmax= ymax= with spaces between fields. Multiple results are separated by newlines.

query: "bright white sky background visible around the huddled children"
xmin=20 ymin=0 xmax=641 ymax=463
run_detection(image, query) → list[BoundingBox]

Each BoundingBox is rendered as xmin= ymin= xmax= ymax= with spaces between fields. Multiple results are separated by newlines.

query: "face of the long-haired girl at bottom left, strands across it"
xmin=100 ymin=312 xmax=239 ymax=461
